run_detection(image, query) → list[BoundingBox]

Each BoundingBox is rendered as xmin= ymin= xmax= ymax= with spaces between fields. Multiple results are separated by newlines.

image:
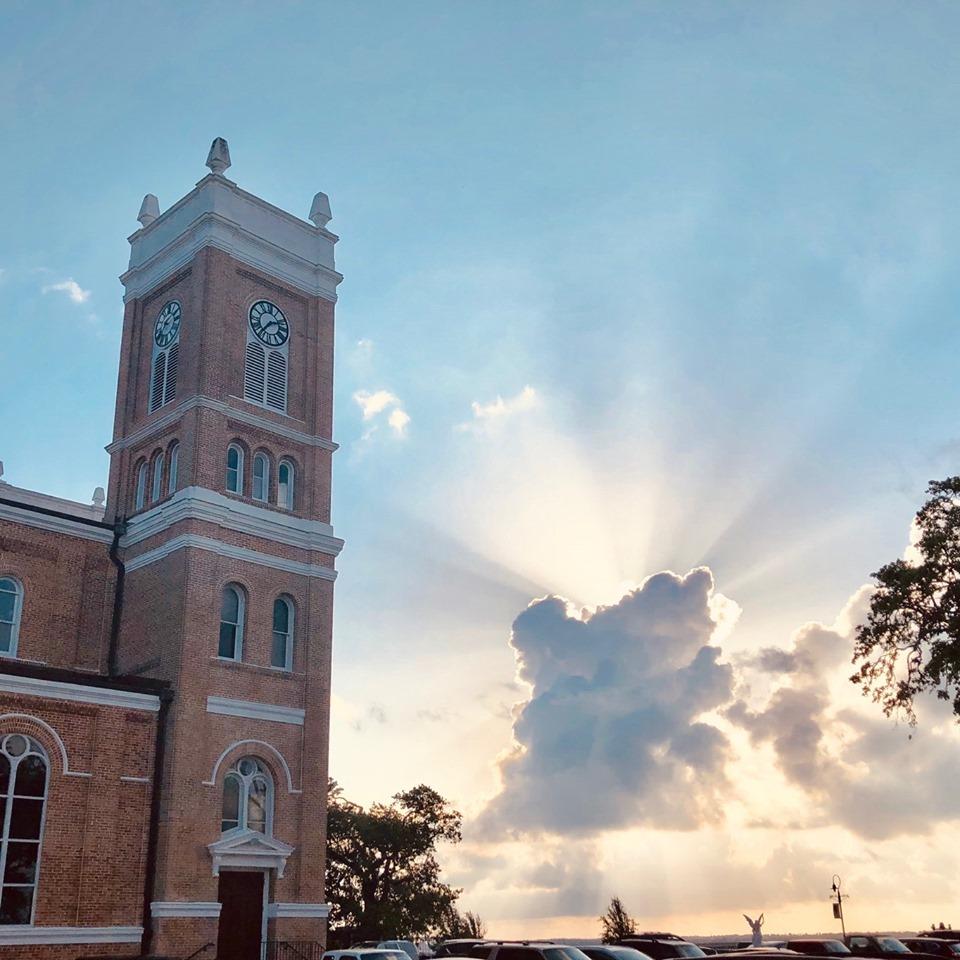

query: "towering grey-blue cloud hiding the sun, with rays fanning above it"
xmin=479 ymin=569 xmax=733 ymax=834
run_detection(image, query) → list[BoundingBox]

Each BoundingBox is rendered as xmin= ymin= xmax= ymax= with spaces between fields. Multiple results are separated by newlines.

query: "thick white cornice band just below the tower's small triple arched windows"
xmin=120 ymin=487 xmax=343 ymax=557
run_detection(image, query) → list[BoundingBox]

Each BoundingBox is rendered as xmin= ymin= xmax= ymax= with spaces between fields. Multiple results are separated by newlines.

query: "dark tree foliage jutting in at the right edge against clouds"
xmin=850 ymin=477 xmax=960 ymax=724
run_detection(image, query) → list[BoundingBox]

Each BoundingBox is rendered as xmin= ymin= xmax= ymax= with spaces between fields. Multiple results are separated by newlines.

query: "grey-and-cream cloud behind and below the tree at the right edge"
xmin=726 ymin=594 xmax=960 ymax=839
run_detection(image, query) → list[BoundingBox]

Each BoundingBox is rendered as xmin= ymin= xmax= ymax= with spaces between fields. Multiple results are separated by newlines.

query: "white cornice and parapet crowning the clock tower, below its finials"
xmin=120 ymin=176 xmax=343 ymax=301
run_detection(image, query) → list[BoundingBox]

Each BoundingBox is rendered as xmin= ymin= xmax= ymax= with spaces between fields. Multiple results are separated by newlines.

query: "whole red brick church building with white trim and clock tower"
xmin=0 ymin=139 xmax=343 ymax=960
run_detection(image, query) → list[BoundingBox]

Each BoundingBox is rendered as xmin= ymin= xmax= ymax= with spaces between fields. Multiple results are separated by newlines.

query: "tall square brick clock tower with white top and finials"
xmin=106 ymin=138 xmax=343 ymax=960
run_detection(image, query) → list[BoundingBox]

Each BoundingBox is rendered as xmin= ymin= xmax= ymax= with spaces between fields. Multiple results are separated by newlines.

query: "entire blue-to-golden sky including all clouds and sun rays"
xmin=0 ymin=0 xmax=960 ymax=937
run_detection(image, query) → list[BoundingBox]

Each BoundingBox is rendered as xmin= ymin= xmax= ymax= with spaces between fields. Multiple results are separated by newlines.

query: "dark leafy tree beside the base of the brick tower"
xmin=327 ymin=781 xmax=462 ymax=940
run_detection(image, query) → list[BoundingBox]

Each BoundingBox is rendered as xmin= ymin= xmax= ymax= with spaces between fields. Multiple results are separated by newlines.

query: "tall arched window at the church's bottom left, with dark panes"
xmin=0 ymin=733 xmax=48 ymax=925
